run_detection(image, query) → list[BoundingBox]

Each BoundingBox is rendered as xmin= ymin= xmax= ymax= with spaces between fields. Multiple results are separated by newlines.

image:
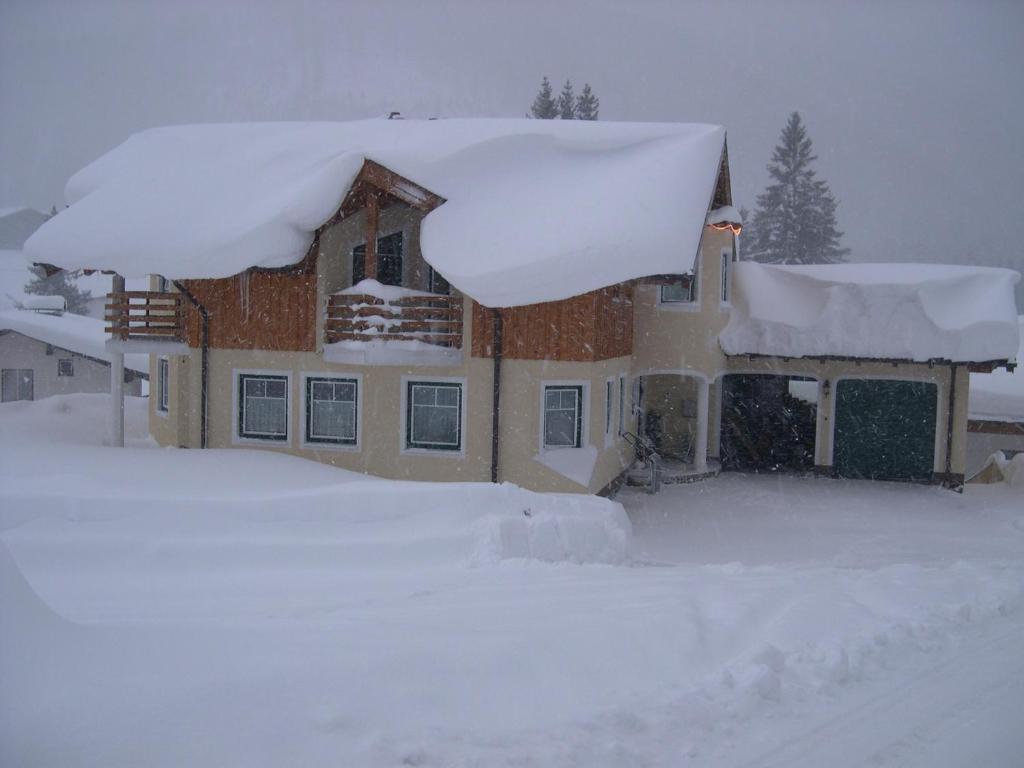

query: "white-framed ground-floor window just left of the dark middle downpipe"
xmin=401 ymin=378 xmax=465 ymax=454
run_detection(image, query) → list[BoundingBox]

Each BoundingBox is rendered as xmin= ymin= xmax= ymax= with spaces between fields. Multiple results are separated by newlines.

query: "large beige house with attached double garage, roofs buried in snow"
xmin=19 ymin=120 xmax=1018 ymax=492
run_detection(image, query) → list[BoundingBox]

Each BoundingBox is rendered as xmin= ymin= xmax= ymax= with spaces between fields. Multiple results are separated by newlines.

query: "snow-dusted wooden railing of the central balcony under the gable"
xmin=324 ymin=294 xmax=462 ymax=349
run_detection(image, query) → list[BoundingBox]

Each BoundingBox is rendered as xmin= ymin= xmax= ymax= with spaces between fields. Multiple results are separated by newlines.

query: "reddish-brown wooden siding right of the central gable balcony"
xmin=472 ymin=283 xmax=633 ymax=362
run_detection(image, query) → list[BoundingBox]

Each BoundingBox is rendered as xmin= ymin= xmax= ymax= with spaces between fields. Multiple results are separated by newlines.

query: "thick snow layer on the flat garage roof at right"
xmin=719 ymin=262 xmax=1020 ymax=362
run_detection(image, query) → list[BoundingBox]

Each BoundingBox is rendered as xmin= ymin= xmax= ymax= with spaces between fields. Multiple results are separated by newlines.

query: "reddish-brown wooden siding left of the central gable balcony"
xmin=184 ymin=257 xmax=316 ymax=352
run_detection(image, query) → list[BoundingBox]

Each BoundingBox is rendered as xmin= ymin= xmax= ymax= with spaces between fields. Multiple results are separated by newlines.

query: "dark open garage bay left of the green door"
xmin=720 ymin=374 xmax=817 ymax=472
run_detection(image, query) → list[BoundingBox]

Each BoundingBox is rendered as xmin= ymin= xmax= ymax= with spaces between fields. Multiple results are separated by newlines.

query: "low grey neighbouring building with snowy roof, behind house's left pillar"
xmin=0 ymin=303 xmax=150 ymax=402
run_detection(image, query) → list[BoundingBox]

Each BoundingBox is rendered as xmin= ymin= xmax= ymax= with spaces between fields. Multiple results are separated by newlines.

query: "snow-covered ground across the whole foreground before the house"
xmin=0 ymin=395 xmax=1024 ymax=768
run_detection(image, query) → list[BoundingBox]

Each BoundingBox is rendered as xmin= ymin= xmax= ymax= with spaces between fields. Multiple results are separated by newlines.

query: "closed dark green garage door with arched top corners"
xmin=833 ymin=379 xmax=938 ymax=480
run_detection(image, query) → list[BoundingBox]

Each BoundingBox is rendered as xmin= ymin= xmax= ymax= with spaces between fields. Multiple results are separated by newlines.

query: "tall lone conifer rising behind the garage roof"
xmin=743 ymin=112 xmax=850 ymax=264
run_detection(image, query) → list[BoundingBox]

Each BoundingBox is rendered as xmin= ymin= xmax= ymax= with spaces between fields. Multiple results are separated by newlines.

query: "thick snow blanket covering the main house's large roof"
xmin=26 ymin=119 xmax=725 ymax=306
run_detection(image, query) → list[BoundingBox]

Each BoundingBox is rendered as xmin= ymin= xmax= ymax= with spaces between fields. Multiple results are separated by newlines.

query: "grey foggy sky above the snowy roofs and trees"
xmin=0 ymin=0 xmax=1024 ymax=276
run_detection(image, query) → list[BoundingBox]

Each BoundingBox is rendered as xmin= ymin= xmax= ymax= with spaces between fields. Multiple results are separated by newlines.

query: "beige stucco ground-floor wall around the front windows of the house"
xmin=151 ymin=342 xmax=631 ymax=493
